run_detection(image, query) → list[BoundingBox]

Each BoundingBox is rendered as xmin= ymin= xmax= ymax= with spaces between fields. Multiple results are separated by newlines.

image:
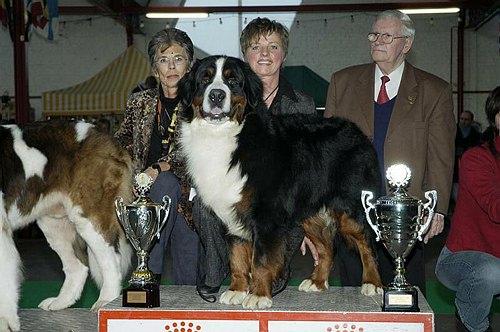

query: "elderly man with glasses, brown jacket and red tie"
xmin=324 ymin=10 xmax=456 ymax=294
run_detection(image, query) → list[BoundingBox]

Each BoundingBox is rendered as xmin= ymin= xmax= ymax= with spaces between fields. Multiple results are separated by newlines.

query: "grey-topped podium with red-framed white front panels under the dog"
xmin=98 ymin=286 xmax=434 ymax=332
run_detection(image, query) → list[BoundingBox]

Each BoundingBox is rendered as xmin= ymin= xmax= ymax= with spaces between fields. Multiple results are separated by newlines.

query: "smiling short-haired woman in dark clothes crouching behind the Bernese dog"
xmin=193 ymin=17 xmax=318 ymax=301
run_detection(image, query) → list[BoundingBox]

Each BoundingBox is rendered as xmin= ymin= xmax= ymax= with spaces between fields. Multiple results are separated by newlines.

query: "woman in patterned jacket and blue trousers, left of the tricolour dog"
xmin=115 ymin=29 xmax=199 ymax=285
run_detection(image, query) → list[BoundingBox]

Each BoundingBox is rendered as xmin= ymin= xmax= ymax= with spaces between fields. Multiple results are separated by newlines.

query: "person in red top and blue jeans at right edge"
xmin=436 ymin=86 xmax=500 ymax=332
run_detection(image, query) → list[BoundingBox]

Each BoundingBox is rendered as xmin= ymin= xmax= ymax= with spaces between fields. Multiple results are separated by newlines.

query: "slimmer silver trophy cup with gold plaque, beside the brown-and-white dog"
xmin=115 ymin=173 xmax=171 ymax=308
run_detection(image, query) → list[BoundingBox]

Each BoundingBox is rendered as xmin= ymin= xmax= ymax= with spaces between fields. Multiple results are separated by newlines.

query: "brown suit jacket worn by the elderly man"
xmin=324 ymin=62 xmax=456 ymax=214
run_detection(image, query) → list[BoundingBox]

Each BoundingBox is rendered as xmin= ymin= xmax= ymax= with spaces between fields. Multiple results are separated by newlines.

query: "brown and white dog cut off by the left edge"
xmin=0 ymin=122 xmax=132 ymax=331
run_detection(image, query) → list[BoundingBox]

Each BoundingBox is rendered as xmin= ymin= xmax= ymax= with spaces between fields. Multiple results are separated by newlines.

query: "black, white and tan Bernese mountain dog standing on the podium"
xmin=179 ymin=56 xmax=382 ymax=309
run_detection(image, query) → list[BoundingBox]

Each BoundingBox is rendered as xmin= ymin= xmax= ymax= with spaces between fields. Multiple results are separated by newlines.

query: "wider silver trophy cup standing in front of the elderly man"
xmin=361 ymin=164 xmax=437 ymax=311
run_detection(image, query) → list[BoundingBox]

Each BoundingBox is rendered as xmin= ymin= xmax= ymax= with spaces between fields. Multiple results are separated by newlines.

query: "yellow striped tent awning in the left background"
xmin=42 ymin=46 xmax=151 ymax=116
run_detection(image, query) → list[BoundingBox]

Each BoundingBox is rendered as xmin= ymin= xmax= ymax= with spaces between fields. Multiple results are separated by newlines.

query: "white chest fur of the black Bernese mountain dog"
xmin=180 ymin=119 xmax=251 ymax=239
